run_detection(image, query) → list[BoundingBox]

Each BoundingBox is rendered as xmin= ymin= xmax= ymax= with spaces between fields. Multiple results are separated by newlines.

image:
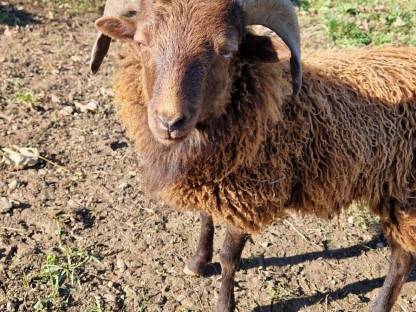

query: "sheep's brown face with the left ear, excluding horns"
xmin=97 ymin=0 xmax=242 ymax=144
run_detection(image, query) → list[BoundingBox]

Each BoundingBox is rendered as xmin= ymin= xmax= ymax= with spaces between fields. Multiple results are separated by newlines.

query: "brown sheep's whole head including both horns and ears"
xmin=92 ymin=0 xmax=301 ymax=145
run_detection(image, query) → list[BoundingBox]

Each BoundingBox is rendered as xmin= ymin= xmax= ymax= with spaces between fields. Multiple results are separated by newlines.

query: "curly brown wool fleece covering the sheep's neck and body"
xmin=116 ymin=48 xmax=416 ymax=251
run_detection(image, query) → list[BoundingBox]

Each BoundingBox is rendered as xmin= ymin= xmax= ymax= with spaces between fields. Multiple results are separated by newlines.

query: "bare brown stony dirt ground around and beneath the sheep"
xmin=0 ymin=1 xmax=416 ymax=312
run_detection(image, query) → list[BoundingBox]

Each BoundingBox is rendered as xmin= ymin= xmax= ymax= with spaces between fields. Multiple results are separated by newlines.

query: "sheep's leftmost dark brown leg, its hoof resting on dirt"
xmin=184 ymin=213 xmax=214 ymax=276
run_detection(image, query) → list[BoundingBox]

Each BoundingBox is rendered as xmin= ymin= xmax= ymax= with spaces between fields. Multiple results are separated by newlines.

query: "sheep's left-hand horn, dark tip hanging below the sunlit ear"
xmin=90 ymin=0 xmax=140 ymax=74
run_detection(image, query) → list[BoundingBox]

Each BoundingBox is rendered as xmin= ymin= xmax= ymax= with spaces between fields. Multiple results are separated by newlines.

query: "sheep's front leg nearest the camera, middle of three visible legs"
xmin=214 ymin=227 xmax=247 ymax=312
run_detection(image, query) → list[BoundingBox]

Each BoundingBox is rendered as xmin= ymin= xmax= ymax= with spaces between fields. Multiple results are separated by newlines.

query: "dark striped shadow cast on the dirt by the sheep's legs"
xmin=206 ymin=236 xmax=416 ymax=312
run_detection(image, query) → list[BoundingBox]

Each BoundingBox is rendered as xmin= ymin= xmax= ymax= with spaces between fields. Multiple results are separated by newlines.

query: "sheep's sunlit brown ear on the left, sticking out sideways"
xmin=95 ymin=16 xmax=136 ymax=40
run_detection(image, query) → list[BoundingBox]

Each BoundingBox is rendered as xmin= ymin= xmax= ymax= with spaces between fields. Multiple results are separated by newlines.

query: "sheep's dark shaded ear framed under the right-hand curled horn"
xmin=240 ymin=33 xmax=291 ymax=63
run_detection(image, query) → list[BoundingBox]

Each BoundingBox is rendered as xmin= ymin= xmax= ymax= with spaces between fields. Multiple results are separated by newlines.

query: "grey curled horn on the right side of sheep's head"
xmin=239 ymin=0 xmax=302 ymax=96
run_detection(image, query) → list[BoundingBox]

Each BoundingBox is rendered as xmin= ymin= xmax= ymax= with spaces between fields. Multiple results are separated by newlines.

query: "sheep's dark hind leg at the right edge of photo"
xmin=371 ymin=244 xmax=415 ymax=312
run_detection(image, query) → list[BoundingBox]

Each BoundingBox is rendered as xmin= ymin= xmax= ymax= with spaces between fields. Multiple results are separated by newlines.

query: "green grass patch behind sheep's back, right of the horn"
xmin=300 ymin=0 xmax=416 ymax=47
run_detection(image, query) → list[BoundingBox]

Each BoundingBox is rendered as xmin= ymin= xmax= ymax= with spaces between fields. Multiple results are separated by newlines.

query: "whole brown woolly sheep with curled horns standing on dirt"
xmin=90 ymin=0 xmax=416 ymax=312
